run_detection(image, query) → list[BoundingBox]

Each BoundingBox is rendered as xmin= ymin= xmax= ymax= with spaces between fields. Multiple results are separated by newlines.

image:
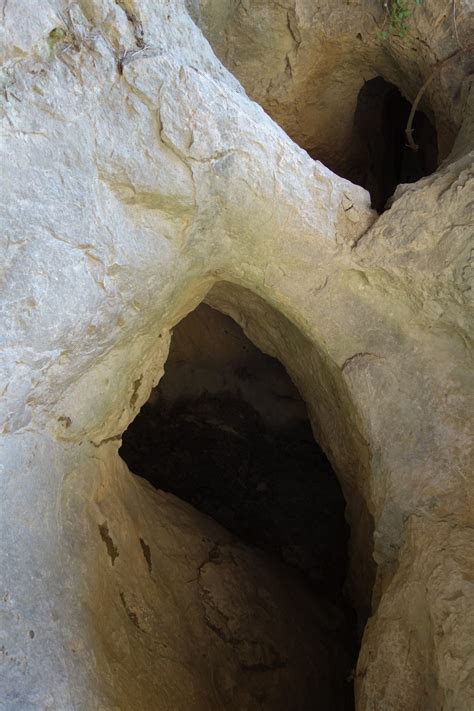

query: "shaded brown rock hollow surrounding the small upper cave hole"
xmin=189 ymin=0 xmax=474 ymax=175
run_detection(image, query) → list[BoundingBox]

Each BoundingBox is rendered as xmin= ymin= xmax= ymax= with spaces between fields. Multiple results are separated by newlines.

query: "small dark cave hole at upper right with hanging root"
xmin=347 ymin=76 xmax=438 ymax=212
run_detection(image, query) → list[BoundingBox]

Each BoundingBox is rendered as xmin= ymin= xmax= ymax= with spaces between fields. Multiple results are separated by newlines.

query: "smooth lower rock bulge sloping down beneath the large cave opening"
xmin=1 ymin=434 xmax=349 ymax=711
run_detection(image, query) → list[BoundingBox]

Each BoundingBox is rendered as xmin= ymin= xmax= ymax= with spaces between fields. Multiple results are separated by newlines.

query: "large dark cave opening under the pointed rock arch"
xmin=120 ymin=304 xmax=357 ymax=709
